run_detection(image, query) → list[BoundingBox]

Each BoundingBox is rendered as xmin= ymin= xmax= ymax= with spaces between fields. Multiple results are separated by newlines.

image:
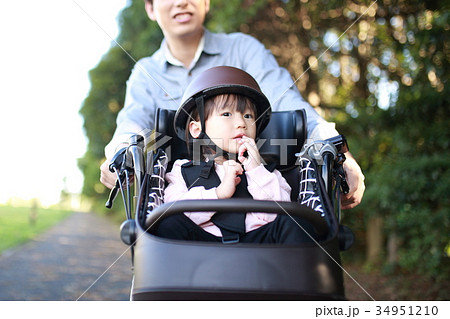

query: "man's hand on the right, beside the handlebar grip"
xmin=341 ymin=152 xmax=366 ymax=209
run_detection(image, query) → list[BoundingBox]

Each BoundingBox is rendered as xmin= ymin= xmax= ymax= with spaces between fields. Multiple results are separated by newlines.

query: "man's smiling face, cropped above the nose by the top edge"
xmin=145 ymin=0 xmax=209 ymax=37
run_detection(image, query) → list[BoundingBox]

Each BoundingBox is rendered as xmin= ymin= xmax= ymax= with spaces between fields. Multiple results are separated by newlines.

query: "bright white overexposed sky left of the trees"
xmin=0 ymin=0 xmax=127 ymax=206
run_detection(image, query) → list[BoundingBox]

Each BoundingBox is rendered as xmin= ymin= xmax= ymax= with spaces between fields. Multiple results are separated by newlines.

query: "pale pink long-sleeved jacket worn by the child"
xmin=164 ymin=160 xmax=291 ymax=237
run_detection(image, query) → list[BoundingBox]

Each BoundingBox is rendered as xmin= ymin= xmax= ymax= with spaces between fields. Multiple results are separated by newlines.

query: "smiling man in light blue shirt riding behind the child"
xmin=100 ymin=0 xmax=365 ymax=209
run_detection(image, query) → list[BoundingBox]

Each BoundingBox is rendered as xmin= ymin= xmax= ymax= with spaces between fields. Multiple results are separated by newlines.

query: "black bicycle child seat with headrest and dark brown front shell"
xmin=131 ymin=109 xmax=345 ymax=300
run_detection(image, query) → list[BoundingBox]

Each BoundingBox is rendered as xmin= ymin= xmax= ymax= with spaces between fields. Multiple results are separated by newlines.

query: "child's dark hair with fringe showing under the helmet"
xmin=185 ymin=93 xmax=256 ymax=160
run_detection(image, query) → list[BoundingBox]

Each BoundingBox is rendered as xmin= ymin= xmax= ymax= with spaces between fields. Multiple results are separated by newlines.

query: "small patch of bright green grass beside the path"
xmin=0 ymin=206 xmax=71 ymax=253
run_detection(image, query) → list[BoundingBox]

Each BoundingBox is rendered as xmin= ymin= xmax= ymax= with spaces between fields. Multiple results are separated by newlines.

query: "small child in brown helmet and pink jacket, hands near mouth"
xmin=155 ymin=67 xmax=320 ymax=244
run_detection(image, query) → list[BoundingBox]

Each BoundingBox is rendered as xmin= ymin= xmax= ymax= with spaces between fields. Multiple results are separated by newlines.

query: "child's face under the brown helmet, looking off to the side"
xmin=191 ymin=95 xmax=256 ymax=154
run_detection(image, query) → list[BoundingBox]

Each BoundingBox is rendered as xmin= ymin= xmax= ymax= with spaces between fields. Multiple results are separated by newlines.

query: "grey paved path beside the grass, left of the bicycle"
xmin=0 ymin=213 xmax=132 ymax=301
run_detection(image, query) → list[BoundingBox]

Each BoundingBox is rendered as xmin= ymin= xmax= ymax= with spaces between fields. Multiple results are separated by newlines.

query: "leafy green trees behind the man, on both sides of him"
xmin=80 ymin=0 xmax=450 ymax=280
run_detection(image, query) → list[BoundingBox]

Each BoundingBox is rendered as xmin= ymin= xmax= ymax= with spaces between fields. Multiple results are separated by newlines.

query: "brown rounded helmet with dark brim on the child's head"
xmin=174 ymin=66 xmax=271 ymax=140
